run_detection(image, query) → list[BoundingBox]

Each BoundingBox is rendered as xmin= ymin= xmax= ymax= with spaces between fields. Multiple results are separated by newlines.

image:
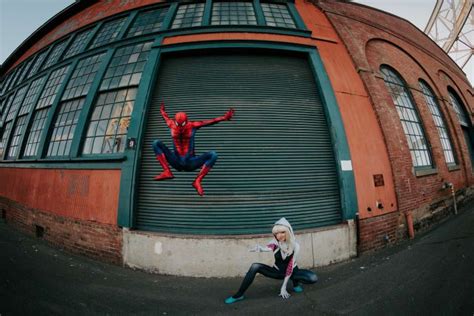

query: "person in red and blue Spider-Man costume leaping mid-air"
xmin=153 ymin=103 xmax=234 ymax=196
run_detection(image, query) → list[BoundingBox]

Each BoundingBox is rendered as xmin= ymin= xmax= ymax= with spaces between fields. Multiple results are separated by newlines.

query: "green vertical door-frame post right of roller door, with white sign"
xmin=309 ymin=49 xmax=358 ymax=220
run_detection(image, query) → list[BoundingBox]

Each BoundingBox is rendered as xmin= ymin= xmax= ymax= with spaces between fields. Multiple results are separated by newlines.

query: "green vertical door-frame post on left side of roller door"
xmin=117 ymin=38 xmax=163 ymax=227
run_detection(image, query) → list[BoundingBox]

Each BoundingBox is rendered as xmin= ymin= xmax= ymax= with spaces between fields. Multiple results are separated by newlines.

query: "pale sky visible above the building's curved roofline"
xmin=0 ymin=0 xmax=474 ymax=83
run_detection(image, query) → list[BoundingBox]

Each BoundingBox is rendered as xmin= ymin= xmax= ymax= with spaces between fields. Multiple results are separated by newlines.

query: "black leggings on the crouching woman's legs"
xmin=233 ymin=263 xmax=318 ymax=298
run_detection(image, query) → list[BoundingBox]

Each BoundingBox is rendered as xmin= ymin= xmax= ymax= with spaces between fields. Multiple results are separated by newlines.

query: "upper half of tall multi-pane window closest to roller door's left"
xmin=100 ymin=42 xmax=152 ymax=91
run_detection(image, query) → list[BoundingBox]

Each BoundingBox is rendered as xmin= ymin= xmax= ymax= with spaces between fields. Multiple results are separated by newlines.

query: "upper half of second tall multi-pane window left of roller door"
xmin=61 ymin=53 xmax=105 ymax=100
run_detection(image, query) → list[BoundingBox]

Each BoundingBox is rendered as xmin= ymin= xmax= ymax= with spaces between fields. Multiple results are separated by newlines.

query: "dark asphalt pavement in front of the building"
xmin=0 ymin=203 xmax=474 ymax=316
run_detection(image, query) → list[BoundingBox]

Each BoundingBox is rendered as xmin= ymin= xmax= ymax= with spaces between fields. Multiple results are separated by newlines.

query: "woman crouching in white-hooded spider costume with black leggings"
xmin=225 ymin=217 xmax=318 ymax=304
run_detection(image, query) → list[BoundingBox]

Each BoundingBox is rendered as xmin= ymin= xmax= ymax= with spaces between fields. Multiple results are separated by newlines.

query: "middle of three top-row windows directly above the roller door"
xmin=211 ymin=1 xmax=257 ymax=25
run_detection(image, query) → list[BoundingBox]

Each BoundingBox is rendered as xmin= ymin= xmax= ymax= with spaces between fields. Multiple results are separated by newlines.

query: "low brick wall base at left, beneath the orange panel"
xmin=0 ymin=197 xmax=122 ymax=264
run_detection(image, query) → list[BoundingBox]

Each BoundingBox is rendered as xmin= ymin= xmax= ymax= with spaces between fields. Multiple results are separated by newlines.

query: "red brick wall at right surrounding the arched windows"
xmin=316 ymin=1 xmax=474 ymax=252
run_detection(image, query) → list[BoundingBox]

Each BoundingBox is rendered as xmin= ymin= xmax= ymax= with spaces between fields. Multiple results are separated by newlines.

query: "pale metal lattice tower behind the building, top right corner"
xmin=425 ymin=0 xmax=474 ymax=76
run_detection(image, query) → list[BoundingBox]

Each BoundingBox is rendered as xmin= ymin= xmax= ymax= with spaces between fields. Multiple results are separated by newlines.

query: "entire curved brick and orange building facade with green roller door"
xmin=0 ymin=0 xmax=474 ymax=276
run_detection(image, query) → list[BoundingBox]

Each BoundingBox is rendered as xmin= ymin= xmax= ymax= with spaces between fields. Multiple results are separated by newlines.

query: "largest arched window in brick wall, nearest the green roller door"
xmin=380 ymin=66 xmax=433 ymax=168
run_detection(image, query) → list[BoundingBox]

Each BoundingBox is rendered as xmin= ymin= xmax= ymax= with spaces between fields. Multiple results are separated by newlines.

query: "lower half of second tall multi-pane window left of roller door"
xmin=47 ymin=98 xmax=85 ymax=157
